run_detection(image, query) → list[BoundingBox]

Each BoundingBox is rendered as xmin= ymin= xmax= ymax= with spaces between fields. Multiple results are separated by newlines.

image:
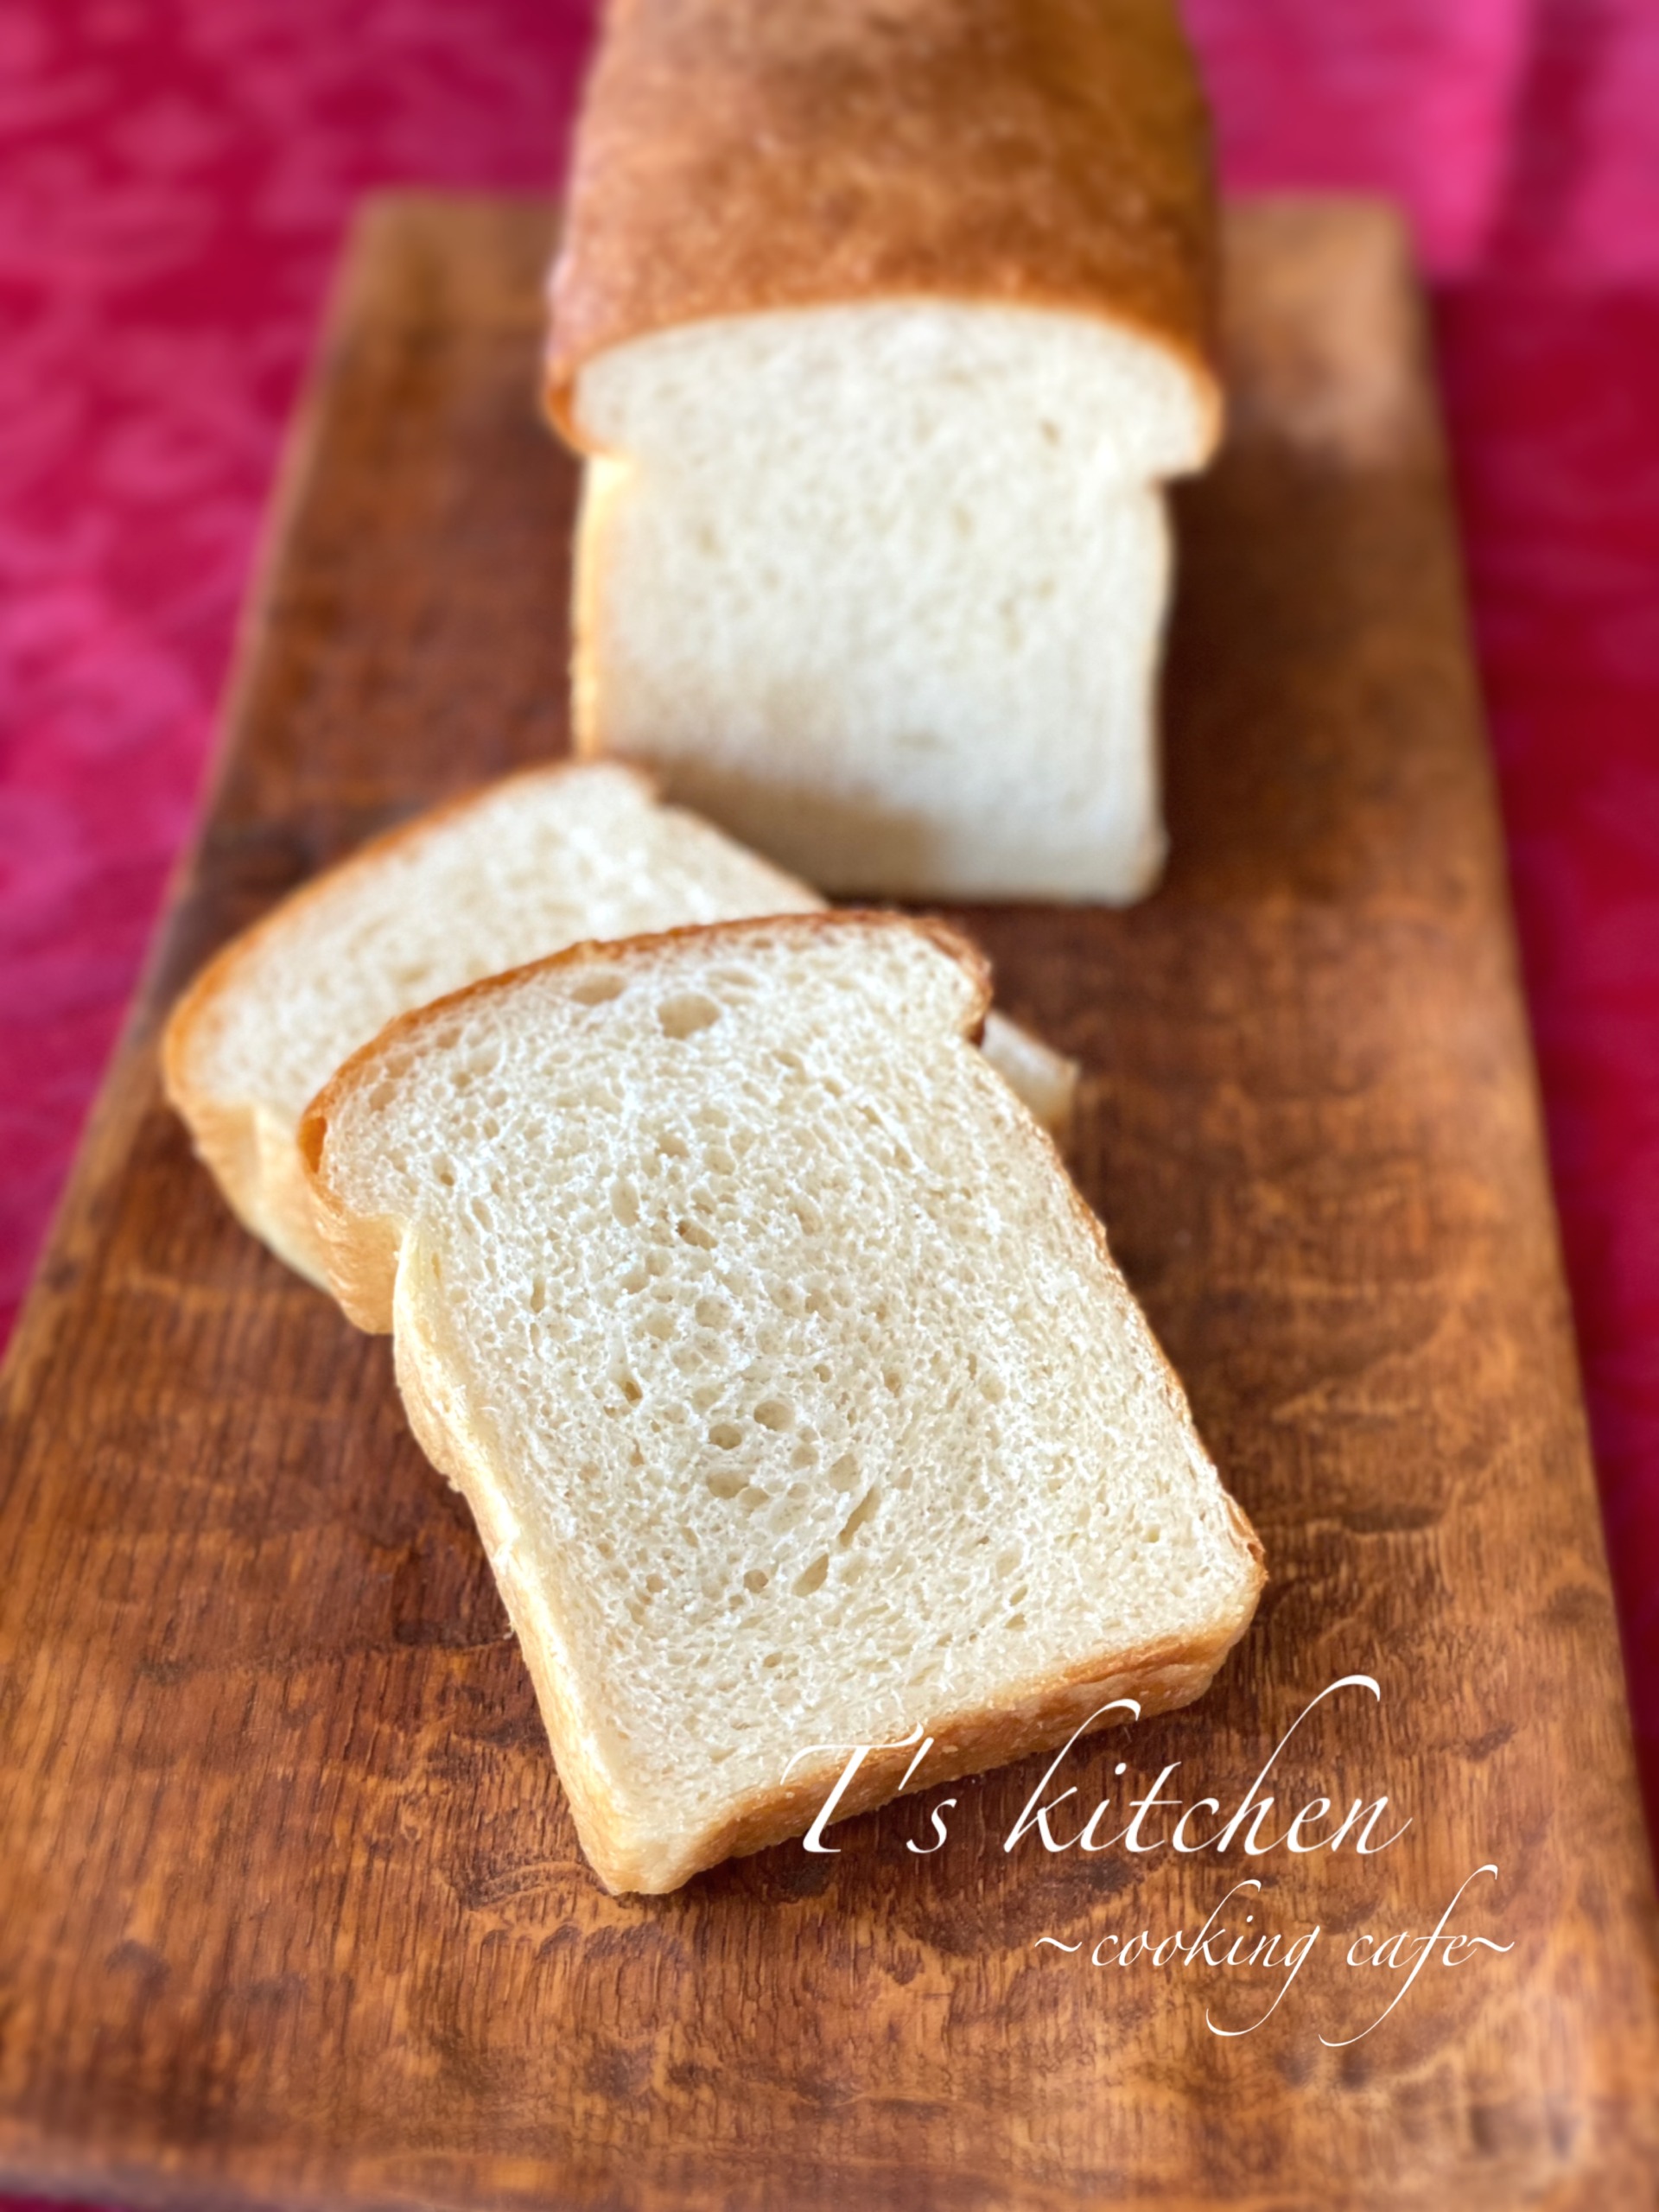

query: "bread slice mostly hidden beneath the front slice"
xmin=162 ymin=763 xmax=1077 ymax=1287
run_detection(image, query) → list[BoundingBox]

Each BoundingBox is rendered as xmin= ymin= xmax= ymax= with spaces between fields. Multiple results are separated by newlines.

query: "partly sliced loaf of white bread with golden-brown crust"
xmin=549 ymin=0 xmax=1221 ymax=902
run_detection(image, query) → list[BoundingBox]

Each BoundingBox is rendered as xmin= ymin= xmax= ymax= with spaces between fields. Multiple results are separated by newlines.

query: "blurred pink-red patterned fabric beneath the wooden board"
xmin=0 ymin=0 xmax=1659 ymax=2167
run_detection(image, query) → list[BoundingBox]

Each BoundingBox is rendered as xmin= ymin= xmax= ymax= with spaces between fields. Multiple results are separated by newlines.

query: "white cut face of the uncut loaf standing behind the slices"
xmin=570 ymin=301 xmax=1214 ymax=902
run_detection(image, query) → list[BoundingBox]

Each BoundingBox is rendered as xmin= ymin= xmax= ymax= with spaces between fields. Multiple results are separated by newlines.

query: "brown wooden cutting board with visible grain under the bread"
xmin=0 ymin=199 xmax=1659 ymax=2212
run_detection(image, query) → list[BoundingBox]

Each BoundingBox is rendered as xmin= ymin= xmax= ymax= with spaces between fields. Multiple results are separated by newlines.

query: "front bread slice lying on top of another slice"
xmin=301 ymin=913 xmax=1263 ymax=1891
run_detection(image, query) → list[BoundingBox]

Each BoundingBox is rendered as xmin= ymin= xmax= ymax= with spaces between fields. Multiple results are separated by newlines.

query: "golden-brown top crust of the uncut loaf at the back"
xmin=549 ymin=0 xmax=1219 ymax=438
